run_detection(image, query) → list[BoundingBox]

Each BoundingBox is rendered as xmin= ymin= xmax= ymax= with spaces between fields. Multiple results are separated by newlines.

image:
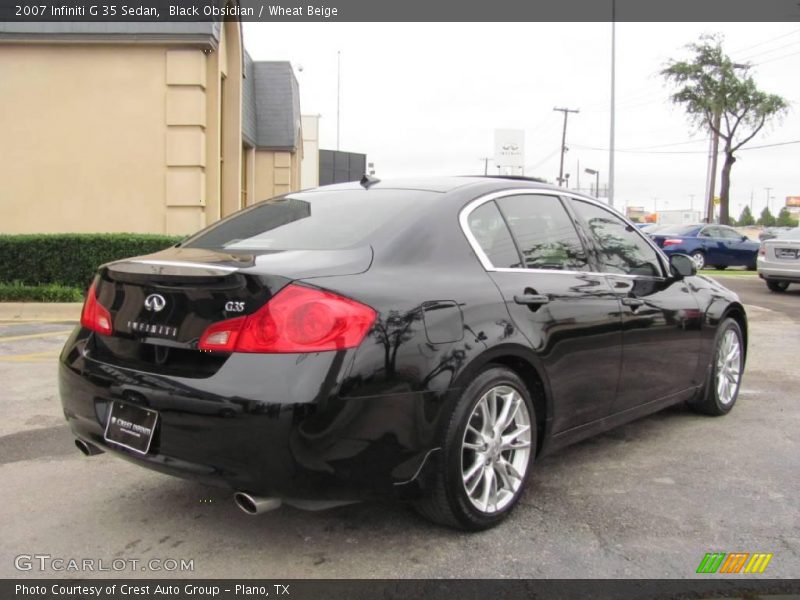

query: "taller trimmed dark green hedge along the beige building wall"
xmin=0 ymin=233 xmax=181 ymax=289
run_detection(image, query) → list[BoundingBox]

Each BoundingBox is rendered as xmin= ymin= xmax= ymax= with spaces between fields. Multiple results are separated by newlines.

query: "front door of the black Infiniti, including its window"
xmin=571 ymin=199 xmax=702 ymax=413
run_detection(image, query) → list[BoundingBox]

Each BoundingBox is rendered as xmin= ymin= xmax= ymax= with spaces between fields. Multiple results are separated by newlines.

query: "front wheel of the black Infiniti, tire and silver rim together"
xmin=689 ymin=318 xmax=744 ymax=416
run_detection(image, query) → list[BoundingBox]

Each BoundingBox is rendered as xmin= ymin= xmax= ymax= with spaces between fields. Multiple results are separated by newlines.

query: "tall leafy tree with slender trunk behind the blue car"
xmin=661 ymin=36 xmax=788 ymax=224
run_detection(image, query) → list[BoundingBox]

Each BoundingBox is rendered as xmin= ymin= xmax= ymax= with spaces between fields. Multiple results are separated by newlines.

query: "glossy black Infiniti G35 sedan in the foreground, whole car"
xmin=60 ymin=177 xmax=747 ymax=530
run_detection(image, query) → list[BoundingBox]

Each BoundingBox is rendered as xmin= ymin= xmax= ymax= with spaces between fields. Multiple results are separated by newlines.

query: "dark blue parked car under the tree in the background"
xmin=650 ymin=224 xmax=758 ymax=270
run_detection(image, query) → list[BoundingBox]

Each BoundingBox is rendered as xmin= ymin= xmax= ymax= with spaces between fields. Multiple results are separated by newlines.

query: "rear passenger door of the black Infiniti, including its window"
xmin=468 ymin=191 xmax=622 ymax=433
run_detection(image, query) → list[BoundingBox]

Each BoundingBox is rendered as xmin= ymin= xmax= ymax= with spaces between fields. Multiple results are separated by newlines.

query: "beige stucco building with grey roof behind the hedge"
xmin=0 ymin=21 xmax=303 ymax=234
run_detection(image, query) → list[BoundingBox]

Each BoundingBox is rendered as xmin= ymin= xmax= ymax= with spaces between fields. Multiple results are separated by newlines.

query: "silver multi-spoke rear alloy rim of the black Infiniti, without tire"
xmin=461 ymin=385 xmax=531 ymax=513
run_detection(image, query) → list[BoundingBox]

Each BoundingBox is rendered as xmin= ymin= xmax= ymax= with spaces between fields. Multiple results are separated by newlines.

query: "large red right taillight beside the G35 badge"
xmin=198 ymin=284 xmax=377 ymax=353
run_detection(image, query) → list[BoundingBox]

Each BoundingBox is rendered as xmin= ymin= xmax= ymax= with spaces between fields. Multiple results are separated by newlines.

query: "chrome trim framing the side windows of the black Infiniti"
xmin=458 ymin=188 xmax=669 ymax=280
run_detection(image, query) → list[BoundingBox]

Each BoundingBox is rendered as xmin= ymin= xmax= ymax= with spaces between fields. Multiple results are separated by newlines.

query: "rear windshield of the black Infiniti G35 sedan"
xmin=182 ymin=190 xmax=437 ymax=251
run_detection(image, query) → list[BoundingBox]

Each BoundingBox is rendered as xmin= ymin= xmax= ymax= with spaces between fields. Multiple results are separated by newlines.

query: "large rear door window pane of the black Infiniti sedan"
xmin=497 ymin=194 xmax=589 ymax=271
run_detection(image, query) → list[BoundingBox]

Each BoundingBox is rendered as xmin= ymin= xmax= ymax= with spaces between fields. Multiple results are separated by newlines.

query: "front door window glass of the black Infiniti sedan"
xmin=572 ymin=200 xmax=662 ymax=277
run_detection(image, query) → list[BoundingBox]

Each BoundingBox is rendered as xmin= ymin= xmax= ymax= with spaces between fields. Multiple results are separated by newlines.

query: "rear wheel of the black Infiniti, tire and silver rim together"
xmin=416 ymin=366 xmax=536 ymax=531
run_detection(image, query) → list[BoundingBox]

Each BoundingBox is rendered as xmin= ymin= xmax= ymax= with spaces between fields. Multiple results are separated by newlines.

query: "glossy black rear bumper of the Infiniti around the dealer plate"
xmin=59 ymin=328 xmax=438 ymax=500
